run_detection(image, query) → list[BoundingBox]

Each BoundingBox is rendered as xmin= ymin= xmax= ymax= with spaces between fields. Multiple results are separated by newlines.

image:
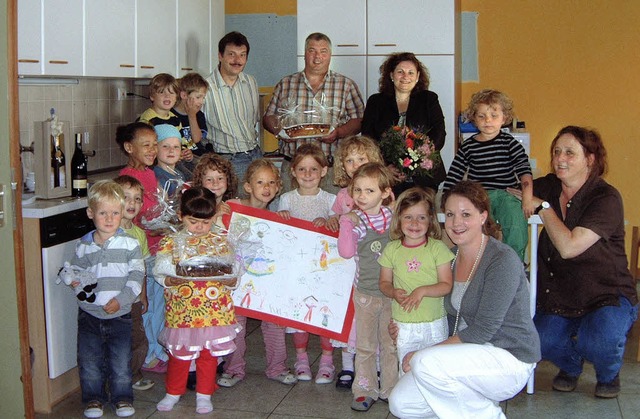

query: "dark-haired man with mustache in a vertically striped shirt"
xmin=204 ymin=32 xmax=262 ymax=185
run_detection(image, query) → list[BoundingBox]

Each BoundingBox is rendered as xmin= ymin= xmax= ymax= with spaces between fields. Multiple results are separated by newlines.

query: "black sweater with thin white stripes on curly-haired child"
xmin=443 ymin=132 xmax=531 ymax=191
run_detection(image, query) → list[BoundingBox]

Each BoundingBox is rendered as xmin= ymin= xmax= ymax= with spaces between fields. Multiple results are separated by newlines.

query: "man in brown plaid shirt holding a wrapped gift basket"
xmin=262 ymin=32 xmax=364 ymax=193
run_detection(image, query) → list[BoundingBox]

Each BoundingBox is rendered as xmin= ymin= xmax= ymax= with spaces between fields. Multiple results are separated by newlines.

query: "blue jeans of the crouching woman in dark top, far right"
xmin=533 ymin=297 xmax=638 ymax=383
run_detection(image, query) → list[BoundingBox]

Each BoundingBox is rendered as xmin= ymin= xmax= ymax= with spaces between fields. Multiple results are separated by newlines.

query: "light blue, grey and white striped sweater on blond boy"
xmin=71 ymin=229 xmax=145 ymax=319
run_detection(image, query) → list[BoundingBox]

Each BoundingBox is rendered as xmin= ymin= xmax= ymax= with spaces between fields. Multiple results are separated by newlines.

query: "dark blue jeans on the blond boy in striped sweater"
xmin=78 ymin=310 xmax=133 ymax=405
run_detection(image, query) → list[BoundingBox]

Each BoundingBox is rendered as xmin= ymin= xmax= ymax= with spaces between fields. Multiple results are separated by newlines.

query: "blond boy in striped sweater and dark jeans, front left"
xmin=71 ymin=180 xmax=144 ymax=418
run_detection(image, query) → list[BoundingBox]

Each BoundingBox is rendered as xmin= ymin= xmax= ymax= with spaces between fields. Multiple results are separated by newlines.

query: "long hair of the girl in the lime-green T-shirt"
xmin=389 ymin=187 xmax=442 ymax=241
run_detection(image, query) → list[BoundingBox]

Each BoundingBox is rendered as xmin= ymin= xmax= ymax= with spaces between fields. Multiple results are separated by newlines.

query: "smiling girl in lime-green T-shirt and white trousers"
xmin=378 ymin=187 xmax=453 ymax=375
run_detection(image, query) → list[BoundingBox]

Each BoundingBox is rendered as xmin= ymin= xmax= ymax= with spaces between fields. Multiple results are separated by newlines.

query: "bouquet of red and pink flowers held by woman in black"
xmin=380 ymin=125 xmax=442 ymax=180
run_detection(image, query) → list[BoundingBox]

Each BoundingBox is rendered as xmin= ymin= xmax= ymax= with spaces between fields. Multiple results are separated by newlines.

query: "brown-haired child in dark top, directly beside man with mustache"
xmin=171 ymin=73 xmax=213 ymax=156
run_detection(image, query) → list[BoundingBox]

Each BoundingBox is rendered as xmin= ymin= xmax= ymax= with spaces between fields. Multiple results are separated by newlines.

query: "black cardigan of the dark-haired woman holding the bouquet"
xmin=362 ymin=90 xmax=447 ymax=189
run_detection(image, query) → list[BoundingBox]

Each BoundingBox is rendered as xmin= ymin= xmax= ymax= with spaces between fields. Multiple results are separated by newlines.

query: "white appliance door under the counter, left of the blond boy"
xmin=42 ymin=240 xmax=78 ymax=378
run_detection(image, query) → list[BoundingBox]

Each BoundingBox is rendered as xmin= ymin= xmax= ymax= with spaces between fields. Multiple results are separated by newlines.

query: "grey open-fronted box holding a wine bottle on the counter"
xmin=33 ymin=121 xmax=74 ymax=199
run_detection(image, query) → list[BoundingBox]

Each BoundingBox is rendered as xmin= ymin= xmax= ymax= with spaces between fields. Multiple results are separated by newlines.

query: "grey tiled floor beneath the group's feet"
xmin=36 ymin=321 xmax=640 ymax=419
